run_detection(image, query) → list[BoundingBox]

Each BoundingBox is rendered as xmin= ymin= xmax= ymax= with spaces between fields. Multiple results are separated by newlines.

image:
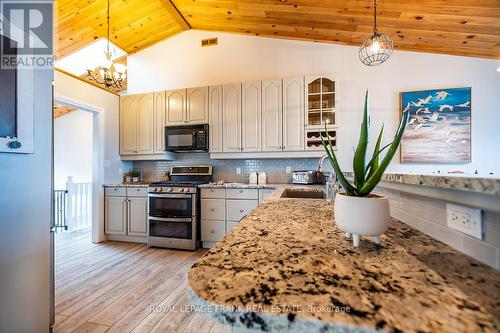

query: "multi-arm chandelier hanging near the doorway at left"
xmin=87 ymin=0 xmax=127 ymax=89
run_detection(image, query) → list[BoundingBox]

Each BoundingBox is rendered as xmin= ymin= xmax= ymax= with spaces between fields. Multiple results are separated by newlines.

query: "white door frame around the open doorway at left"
xmin=52 ymin=94 xmax=106 ymax=243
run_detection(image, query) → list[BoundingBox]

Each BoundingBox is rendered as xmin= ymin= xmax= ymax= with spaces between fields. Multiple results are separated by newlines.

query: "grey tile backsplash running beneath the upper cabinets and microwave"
xmin=134 ymin=153 xmax=322 ymax=183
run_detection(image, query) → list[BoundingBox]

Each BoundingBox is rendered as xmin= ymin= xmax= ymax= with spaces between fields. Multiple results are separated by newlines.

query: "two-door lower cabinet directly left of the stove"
xmin=104 ymin=187 xmax=148 ymax=243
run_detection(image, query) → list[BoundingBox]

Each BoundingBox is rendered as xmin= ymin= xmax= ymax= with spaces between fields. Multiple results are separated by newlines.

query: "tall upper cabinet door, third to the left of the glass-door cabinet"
xmin=241 ymin=81 xmax=262 ymax=152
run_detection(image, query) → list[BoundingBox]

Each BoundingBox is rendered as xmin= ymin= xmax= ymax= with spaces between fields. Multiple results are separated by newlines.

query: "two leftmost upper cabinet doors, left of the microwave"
xmin=120 ymin=94 xmax=154 ymax=155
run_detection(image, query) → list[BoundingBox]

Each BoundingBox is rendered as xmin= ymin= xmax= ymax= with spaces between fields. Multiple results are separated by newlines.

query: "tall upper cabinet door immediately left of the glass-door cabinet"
xmin=283 ymin=77 xmax=305 ymax=151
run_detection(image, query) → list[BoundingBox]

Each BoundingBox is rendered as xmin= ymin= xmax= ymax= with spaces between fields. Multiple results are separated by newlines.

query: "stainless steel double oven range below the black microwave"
xmin=148 ymin=165 xmax=212 ymax=250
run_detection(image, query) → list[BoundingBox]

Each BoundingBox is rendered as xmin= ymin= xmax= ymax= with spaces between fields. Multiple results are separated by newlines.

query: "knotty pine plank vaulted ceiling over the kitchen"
xmin=55 ymin=0 xmax=500 ymax=59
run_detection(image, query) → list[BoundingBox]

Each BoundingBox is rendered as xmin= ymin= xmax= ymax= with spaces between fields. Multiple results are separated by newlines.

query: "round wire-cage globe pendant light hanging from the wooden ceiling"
xmin=359 ymin=0 xmax=394 ymax=66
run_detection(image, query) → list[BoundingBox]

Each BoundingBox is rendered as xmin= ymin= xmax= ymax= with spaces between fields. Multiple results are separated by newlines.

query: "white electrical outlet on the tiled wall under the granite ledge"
xmin=446 ymin=204 xmax=483 ymax=239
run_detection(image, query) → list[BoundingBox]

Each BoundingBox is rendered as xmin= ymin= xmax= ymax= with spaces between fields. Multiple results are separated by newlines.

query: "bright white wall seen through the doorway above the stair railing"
xmin=54 ymin=110 xmax=93 ymax=189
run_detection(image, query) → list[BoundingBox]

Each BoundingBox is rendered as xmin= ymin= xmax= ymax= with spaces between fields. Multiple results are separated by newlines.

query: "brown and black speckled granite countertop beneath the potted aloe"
xmin=188 ymin=186 xmax=500 ymax=333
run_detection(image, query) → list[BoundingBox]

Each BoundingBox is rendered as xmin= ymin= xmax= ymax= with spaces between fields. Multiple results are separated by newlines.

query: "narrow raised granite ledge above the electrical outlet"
xmin=345 ymin=172 xmax=500 ymax=195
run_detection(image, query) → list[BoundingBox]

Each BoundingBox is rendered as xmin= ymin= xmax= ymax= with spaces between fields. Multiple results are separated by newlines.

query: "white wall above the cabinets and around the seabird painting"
xmin=128 ymin=30 xmax=500 ymax=177
